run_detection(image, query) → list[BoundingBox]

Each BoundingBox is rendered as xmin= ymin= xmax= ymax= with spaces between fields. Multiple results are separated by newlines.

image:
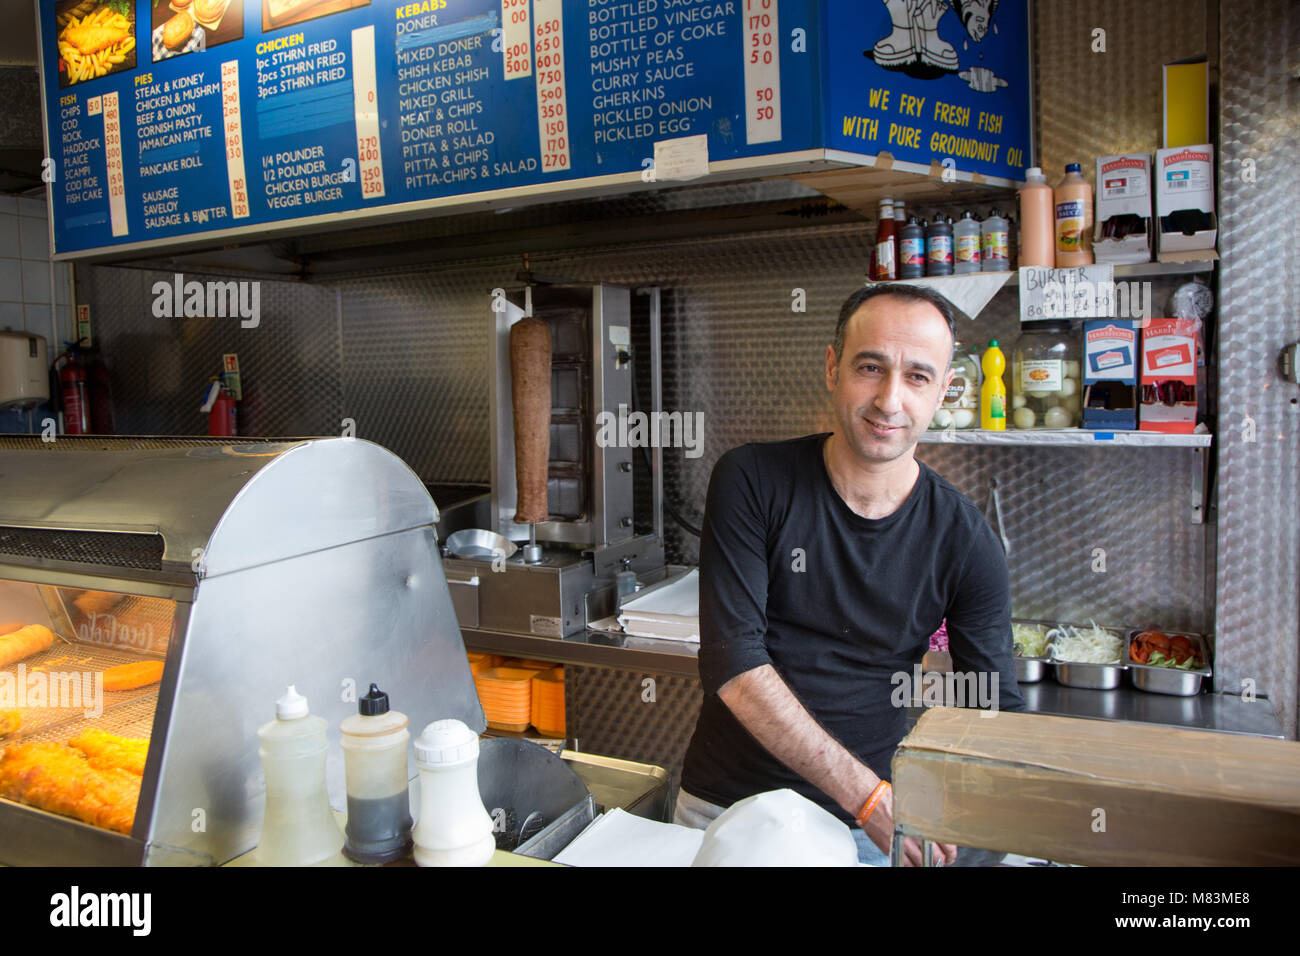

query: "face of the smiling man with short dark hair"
xmin=826 ymin=295 xmax=953 ymax=463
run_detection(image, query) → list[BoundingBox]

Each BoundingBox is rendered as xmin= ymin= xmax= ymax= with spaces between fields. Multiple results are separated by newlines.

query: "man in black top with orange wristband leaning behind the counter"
xmin=676 ymin=284 xmax=1024 ymax=865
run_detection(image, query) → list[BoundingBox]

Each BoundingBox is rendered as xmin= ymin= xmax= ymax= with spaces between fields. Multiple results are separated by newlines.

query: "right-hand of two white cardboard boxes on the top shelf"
xmin=1154 ymin=144 xmax=1218 ymax=263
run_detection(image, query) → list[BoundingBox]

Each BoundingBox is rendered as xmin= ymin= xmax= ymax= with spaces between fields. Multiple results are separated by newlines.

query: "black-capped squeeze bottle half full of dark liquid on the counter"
xmin=339 ymin=684 xmax=411 ymax=864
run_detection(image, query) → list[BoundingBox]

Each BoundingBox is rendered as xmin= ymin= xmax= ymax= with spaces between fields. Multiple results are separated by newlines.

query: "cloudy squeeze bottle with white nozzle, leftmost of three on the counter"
xmin=256 ymin=684 xmax=347 ymax=866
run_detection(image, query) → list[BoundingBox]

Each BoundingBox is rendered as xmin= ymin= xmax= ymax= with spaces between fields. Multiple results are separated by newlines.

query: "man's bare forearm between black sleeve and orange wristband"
xmin=718 ymin=665 xmax=880 ymax=814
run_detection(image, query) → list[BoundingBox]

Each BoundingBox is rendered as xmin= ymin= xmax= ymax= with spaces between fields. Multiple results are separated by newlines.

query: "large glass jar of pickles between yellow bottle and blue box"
xmin=1011 ymin=319 xmax=1083 ymax=429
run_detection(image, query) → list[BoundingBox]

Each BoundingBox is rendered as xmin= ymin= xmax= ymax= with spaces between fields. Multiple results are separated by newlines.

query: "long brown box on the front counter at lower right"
xmin=893 ymin=708 xmax=1300 ymax=866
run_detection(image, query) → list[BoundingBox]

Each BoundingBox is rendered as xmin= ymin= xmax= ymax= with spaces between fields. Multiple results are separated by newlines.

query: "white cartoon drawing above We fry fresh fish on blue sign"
xmin=863 ymin=0 xmax=1006 ymax=92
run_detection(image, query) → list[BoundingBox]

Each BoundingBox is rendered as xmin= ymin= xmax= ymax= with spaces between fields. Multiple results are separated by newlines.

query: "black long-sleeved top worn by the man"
xmin=681 ymin=434 xmax=1024 ymax=822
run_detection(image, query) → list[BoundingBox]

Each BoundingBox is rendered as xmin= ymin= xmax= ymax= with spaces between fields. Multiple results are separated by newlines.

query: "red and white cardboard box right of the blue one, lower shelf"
xmin=1139 ymin=319 xmax=1201 ymax=434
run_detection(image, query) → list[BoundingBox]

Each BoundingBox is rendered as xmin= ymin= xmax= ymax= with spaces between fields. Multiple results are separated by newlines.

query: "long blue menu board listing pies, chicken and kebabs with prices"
xmin=38 ymin=0 xmax=1014 ymax=256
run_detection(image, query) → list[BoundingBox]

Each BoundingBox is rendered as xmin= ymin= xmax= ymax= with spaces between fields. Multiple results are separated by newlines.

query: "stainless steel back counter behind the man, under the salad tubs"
xmin=462 ymin=628 xmax=1284 ymax=737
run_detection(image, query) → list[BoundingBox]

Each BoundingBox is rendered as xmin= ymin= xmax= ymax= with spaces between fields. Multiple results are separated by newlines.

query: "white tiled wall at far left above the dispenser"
xmin=0 ymin=196 xmax=74 ymax=345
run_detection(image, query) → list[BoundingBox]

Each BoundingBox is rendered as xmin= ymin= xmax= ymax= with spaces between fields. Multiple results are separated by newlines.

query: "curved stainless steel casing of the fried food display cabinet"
xmin=0 ymin=438 xmax=486 ymax=864
